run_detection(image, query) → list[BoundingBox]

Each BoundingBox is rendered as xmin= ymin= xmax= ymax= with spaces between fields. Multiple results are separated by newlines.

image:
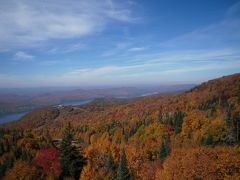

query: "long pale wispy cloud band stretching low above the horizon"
xmin=0 ymin=49 xmax=240 ymax=86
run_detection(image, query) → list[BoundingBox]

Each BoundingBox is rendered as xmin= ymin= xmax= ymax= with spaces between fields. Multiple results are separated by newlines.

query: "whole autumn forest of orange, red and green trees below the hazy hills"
xmin=0 ymin=73 xmax=240 ymax=180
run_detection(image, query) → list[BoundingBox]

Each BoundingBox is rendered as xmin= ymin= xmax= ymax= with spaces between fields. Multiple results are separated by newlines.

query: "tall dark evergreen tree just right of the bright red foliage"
xmin=60 ymin=123 xmax=85 ymax=179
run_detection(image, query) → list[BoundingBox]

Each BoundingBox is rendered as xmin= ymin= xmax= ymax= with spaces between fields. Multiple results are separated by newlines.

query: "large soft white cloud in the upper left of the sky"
xmin=0 ymin=0 xmax=135 ymax=48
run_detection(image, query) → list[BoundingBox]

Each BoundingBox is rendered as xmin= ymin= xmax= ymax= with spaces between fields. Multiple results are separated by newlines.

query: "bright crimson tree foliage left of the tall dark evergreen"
xmin=34 ymin=147 xmax=61 ymax=177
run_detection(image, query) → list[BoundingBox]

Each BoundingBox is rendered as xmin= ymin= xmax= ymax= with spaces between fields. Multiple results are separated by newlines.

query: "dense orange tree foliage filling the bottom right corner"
xmin=156 ymin=147 xmax=240 ymax=180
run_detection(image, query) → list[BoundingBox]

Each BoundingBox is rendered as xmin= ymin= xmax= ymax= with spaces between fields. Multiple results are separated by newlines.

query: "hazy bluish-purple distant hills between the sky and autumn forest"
xmin=0 ymin=84 xmax=195 ymax=115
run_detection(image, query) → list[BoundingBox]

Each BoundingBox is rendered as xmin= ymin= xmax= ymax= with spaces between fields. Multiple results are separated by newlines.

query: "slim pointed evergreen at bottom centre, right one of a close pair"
xmin=117 ymin=150 xmax=130 ymax=180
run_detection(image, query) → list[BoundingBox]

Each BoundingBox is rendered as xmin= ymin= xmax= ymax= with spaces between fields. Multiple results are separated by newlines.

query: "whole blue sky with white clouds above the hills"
xmin=0 ymin=0 xmax=240 ymax=88
